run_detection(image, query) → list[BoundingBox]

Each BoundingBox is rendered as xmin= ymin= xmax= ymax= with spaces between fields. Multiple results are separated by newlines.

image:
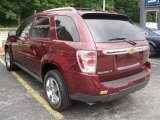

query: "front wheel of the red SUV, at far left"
xmin=5 ymin=49 xmax=15 ymax=71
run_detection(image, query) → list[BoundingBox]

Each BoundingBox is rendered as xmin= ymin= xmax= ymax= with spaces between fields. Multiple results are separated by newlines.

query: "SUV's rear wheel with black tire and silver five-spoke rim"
xmin=43 ymin=70 xmax=71 ymax=111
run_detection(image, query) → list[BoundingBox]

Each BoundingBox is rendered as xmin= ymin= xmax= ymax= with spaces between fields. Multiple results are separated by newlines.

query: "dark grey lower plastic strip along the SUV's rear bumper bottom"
xmin=70 ymin=80 xmax=148 ymax=103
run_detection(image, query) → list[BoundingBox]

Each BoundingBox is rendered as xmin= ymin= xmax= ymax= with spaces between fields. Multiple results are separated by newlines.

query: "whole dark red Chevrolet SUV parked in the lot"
xmin=5 ymin=7 xmax=151 ymax=111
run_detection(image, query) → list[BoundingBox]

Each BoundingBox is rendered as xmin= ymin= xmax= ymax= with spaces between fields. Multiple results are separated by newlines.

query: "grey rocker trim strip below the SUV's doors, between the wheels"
xmin=14 ymin=62 xmax=43 ymax=82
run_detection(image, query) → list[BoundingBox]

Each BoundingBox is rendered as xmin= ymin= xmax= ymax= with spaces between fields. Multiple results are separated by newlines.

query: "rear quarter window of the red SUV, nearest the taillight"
xmin=55 ymin=16 xmax=79 ymax=41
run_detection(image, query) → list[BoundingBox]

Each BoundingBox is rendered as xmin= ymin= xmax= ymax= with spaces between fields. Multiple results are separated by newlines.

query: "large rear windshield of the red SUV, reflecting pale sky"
xmin=84 ymin=19 xmax=145 ymax=43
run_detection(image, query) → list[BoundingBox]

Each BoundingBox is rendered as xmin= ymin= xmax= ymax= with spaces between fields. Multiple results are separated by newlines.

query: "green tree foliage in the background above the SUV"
xmin=0 ymin=0 xmax=154 ymax=26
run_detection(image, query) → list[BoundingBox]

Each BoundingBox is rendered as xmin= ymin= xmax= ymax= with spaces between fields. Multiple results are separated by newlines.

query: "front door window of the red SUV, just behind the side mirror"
xmin=18 ymin=18 xmax=33 ymax=38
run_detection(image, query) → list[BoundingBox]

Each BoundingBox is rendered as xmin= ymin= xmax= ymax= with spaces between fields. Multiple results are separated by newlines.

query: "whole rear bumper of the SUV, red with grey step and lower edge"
xmin=65 ymin=62 xmax=151 ymax=103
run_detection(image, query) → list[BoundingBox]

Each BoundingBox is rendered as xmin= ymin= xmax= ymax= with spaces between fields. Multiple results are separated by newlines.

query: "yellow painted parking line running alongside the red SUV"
xmin=0 ymin=58 xmax=63 ymax=120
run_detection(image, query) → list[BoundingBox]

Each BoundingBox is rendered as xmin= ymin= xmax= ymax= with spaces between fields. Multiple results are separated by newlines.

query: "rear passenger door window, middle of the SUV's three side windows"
xmin=32 ymin=17 xmax=50 ymax=38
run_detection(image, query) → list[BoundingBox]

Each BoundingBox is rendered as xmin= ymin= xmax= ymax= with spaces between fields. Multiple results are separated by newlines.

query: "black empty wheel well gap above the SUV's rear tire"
xmin=41 ymin=63 xmax=58 ymax=80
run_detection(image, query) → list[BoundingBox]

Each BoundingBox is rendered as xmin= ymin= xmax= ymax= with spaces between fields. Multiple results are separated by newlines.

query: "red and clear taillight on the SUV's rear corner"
xmin=76 ymin=50 xmax=97 ymax=73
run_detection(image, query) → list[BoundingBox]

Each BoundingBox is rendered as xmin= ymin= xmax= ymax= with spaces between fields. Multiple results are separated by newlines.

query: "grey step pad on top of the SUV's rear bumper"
xmin=101 ymin=71 xmax=149 ymax=87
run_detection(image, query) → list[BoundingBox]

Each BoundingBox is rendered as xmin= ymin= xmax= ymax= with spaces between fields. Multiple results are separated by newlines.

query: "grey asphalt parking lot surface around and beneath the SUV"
xmin=0 ymin=56 xmax=160 ymax=120
